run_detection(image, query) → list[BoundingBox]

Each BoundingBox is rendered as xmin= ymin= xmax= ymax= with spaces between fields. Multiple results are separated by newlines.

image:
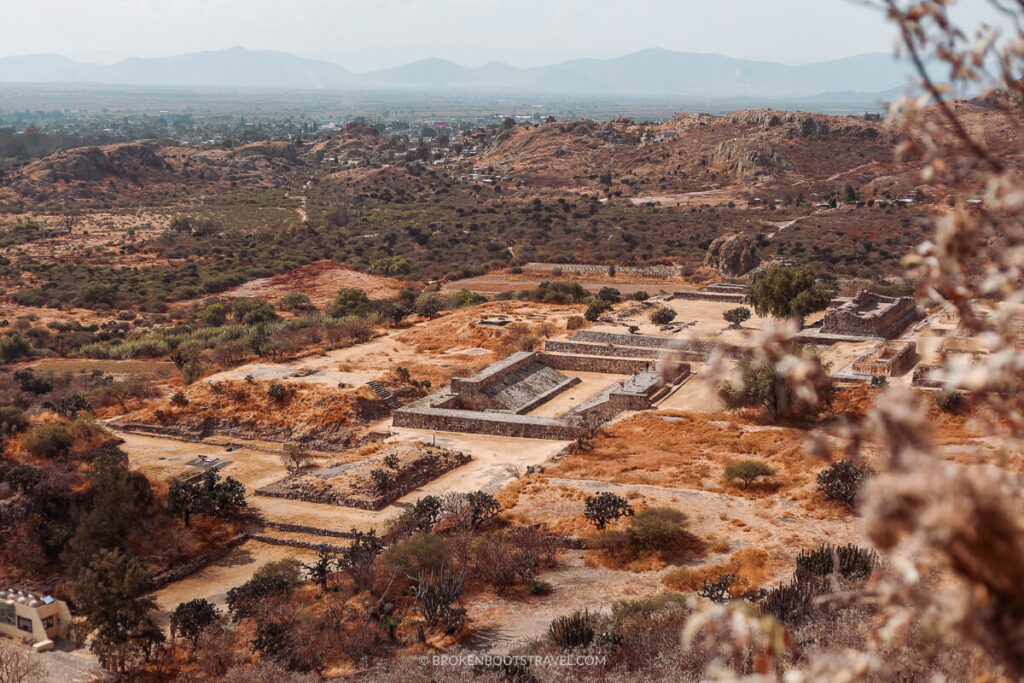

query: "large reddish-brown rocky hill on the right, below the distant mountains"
xmin=479 ymin=110 xmax=893 ymax=195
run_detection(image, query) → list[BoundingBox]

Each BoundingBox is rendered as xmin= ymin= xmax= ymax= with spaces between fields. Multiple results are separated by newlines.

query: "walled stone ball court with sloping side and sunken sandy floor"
xmin=393 ymin=350 xmax=690 ymax=440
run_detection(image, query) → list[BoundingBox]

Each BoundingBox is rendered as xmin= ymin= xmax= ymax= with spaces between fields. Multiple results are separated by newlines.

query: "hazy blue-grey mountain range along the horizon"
xmin=0 ymin=47 xmax=910 ymax=98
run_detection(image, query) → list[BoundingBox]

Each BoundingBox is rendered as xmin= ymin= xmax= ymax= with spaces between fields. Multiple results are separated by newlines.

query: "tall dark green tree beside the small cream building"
xmin=68 ymin=550 xmax=161 ymax=673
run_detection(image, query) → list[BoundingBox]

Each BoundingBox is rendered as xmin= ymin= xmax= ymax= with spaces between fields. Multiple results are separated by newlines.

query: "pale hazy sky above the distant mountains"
xmin=0 ymin=0 xmax=995 ymax=71
